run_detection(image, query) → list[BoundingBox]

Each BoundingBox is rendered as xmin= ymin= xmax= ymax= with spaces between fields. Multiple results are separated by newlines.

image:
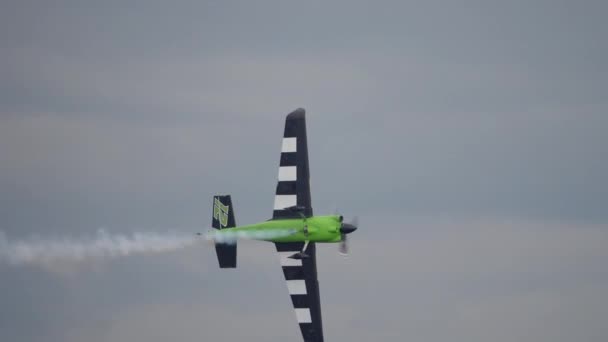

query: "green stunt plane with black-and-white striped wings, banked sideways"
xmin=199 ymin=108 xmax=357 ymax=342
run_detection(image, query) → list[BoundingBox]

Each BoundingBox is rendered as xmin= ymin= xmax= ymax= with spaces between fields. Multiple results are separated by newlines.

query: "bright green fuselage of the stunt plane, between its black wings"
xmin=222 ymin=215 xmax=342 ymax=242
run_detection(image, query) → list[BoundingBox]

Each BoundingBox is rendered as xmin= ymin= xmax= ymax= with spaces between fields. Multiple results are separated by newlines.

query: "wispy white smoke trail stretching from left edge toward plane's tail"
xmin=0 ymin=231 xmax=197 ymax=266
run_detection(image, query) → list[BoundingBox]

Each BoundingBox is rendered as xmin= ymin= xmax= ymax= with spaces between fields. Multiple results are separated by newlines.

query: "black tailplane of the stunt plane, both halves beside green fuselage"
xmin=211 ymin=195 xmax=236 ymax=268
